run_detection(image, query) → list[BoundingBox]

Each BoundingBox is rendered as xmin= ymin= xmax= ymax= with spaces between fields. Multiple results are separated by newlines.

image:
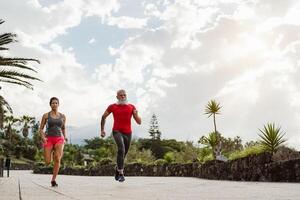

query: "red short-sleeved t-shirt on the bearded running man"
xmin=106 ymin=103 xmax=135 ymax=134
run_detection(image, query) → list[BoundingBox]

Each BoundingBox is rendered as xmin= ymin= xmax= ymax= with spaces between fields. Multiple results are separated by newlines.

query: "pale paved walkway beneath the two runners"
xmin=0 ymin=171 xmax=300 ymax=200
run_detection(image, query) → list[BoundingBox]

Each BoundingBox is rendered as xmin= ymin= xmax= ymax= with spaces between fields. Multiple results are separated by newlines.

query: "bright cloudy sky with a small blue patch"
xmin=0 ymin=0 xmax=300 ymax=149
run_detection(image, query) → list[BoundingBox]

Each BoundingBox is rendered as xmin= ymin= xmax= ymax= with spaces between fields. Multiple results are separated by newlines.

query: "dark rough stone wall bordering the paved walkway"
xmin=34 ymin=153 xmax=300 ymax=182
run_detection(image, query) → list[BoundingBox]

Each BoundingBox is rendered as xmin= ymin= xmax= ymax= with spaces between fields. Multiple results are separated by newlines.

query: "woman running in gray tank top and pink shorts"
xmin=39 ymin=97 xmax=67 ymax=187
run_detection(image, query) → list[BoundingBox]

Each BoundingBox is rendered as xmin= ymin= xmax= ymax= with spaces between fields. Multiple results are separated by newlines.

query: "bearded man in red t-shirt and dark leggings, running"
xmin=100 ymin=90 xmax=142 ymax=182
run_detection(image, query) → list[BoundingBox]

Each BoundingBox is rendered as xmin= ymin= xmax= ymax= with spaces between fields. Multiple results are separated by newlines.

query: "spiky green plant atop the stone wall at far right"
xmin=258 ymin=123 xmax=286 ymax=154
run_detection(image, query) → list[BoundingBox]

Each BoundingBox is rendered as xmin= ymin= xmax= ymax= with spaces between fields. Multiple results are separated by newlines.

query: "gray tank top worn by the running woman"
xmin=46 ymin=112 xmax=63 ymax=137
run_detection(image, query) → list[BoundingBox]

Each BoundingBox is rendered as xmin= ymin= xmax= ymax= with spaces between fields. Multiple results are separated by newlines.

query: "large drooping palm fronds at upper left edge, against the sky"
xmin=0 ymin=19 xmax=41 ymax=89
